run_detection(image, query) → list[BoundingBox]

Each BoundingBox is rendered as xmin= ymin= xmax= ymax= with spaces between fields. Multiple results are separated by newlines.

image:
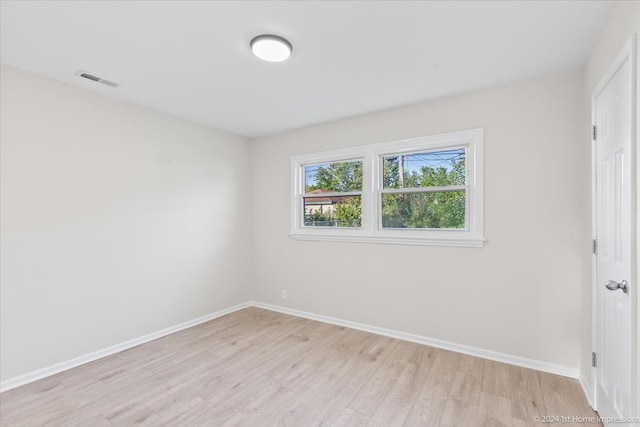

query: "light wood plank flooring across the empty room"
xmin=0 ymin=308 xmax=598 ymax=427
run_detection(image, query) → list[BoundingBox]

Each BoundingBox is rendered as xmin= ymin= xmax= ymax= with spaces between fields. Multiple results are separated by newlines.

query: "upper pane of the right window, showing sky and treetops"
xmin=382 ymin=148 xmax=466 ymax=188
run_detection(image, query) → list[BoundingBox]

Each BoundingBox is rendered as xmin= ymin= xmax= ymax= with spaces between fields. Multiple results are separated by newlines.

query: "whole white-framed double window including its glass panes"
xmin=290 ymin=129 xmax=484 ymax=247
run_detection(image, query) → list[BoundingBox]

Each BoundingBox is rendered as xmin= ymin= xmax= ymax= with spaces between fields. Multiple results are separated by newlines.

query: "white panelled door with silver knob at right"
xmin=593 ymin=36 xmax=637 ymax=425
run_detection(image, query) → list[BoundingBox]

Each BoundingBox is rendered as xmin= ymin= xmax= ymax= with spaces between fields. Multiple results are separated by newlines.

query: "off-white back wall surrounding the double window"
xmin=251 ymin=72 xmax=589 ymax=369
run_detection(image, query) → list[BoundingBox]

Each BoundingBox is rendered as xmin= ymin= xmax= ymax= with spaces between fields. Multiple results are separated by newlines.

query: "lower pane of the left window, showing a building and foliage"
xmin=304 ymin=196 xmax=362 ymax=227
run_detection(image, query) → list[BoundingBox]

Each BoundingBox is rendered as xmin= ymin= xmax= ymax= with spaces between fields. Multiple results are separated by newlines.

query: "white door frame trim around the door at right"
xmin=591 ymin=34 xmax=640 ymax=416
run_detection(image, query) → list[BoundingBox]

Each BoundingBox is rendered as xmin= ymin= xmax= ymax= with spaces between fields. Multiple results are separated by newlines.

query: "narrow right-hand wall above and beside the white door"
xmin=581 ymin=1 xmax=640 ymax=414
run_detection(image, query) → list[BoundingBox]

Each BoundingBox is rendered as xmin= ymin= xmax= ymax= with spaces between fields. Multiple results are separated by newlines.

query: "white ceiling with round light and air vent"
xmin=0 ymin=0 xmax=611 ymax=137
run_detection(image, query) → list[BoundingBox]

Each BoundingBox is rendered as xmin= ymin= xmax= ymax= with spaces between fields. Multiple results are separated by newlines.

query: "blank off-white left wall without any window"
xmin=0 ymin=67 xmax=250 ymax=380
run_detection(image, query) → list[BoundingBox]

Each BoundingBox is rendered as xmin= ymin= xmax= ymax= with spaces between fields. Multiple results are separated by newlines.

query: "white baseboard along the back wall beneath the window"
xmin=251 ymin=301 xmax=580 ymax=379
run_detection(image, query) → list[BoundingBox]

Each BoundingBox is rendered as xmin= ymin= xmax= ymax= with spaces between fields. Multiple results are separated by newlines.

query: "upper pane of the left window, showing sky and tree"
xmin=304 ymin=161 xmax=362 ymax=193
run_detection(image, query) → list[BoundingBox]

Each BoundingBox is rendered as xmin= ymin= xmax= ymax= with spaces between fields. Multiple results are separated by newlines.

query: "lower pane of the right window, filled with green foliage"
xmin=382 ymin=191 xmax=465 ymax=229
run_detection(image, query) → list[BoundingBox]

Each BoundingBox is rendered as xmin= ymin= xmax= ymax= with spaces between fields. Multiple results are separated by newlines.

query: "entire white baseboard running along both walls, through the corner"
xmin=0 ymin=301 xmax=580 ymax=394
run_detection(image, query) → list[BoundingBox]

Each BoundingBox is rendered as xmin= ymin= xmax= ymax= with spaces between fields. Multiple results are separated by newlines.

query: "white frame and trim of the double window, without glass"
xmin=289 ymin=129 xmax=485 ymax=247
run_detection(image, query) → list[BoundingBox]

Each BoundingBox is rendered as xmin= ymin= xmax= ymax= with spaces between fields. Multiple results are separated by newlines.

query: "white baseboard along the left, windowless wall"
xmin=0 ymin=302 xmax=252 ymax=393
